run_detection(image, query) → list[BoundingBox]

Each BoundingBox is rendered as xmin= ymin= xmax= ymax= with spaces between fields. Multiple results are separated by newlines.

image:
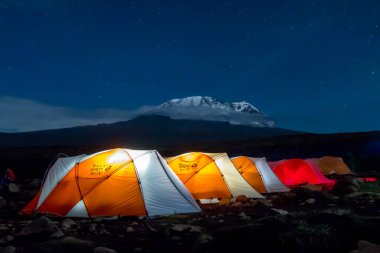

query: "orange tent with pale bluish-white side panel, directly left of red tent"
xmin=231 ymin=156 xmax=289 ymax=193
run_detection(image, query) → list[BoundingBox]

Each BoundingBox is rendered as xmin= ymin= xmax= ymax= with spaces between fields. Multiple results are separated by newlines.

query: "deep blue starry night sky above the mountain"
xmin=0 ymin=0 xmax=380 ymax=133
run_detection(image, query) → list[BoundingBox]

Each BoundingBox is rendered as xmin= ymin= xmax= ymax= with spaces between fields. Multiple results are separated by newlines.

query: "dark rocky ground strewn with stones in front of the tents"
xmin=0 ymin=177 xmax=380 ymax=253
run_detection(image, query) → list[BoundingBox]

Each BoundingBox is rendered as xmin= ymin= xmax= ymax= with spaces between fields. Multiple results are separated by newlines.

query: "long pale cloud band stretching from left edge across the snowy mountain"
xmin=0 ymin=97 xmax=274 ymax=133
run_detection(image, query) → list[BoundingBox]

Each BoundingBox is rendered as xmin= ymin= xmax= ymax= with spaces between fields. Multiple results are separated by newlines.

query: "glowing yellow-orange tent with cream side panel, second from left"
xmin=166 ymin=152 xmax=264 ymax=200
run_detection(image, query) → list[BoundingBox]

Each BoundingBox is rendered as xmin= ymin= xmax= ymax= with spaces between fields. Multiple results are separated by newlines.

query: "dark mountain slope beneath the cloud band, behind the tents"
xmin=0 ymin=115 xmax=300 ymax=149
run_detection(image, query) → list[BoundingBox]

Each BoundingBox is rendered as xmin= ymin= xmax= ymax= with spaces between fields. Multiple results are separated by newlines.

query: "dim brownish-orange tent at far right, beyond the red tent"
xmin=317 ymin=156 xmax=352 ymax=175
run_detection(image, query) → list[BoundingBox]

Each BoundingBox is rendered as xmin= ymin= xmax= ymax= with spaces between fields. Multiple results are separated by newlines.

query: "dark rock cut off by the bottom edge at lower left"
xmin=32 ymin=236 xmax=94 ymax=253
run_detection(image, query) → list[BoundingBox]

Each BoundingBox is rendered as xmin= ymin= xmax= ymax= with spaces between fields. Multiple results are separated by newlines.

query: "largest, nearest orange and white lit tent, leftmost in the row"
xmin=21 ymin=149 xmax=200 ymax=217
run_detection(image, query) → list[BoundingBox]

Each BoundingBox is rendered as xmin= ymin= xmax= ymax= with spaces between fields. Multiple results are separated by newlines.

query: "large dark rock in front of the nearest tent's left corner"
xmin=18 ymin=216 xmax=65 ymax=238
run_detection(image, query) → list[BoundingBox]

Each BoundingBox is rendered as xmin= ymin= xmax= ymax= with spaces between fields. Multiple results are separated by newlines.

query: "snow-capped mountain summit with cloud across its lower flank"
xmin=142 ymin=96 xmax=275 ymax=127
